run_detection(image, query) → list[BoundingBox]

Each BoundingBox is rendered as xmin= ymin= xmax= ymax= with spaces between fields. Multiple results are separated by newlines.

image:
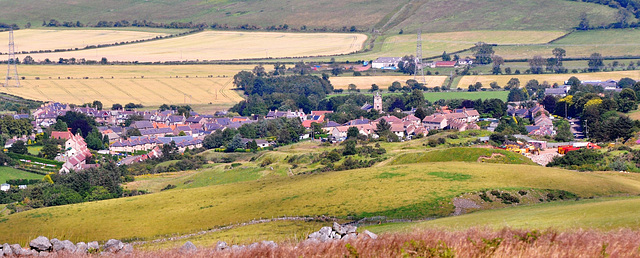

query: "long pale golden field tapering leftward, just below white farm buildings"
xmin=11 ymin=31 xmax=367 ymax=62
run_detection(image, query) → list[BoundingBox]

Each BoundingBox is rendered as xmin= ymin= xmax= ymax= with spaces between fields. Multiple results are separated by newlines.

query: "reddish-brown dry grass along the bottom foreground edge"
xmin=121 ymin=228 xmax=640 ymax=257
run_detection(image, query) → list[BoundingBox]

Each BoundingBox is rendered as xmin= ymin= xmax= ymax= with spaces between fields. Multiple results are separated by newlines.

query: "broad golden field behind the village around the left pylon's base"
xmin=0 ymin=65 xmax=253 ymax=110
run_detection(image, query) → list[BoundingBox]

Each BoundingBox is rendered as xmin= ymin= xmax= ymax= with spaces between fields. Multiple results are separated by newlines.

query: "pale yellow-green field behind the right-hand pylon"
xmin=336 ymin=30 xmax=565 ymax=60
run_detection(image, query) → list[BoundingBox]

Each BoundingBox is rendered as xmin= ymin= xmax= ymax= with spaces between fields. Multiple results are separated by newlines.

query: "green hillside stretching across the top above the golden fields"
xmin=0 ymin=0 xmax=616 ymax=33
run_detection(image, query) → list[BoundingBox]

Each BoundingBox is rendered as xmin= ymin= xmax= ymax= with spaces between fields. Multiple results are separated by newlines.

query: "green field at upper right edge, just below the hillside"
xmin=494 ymin=29 xmax=640 ymax=59
